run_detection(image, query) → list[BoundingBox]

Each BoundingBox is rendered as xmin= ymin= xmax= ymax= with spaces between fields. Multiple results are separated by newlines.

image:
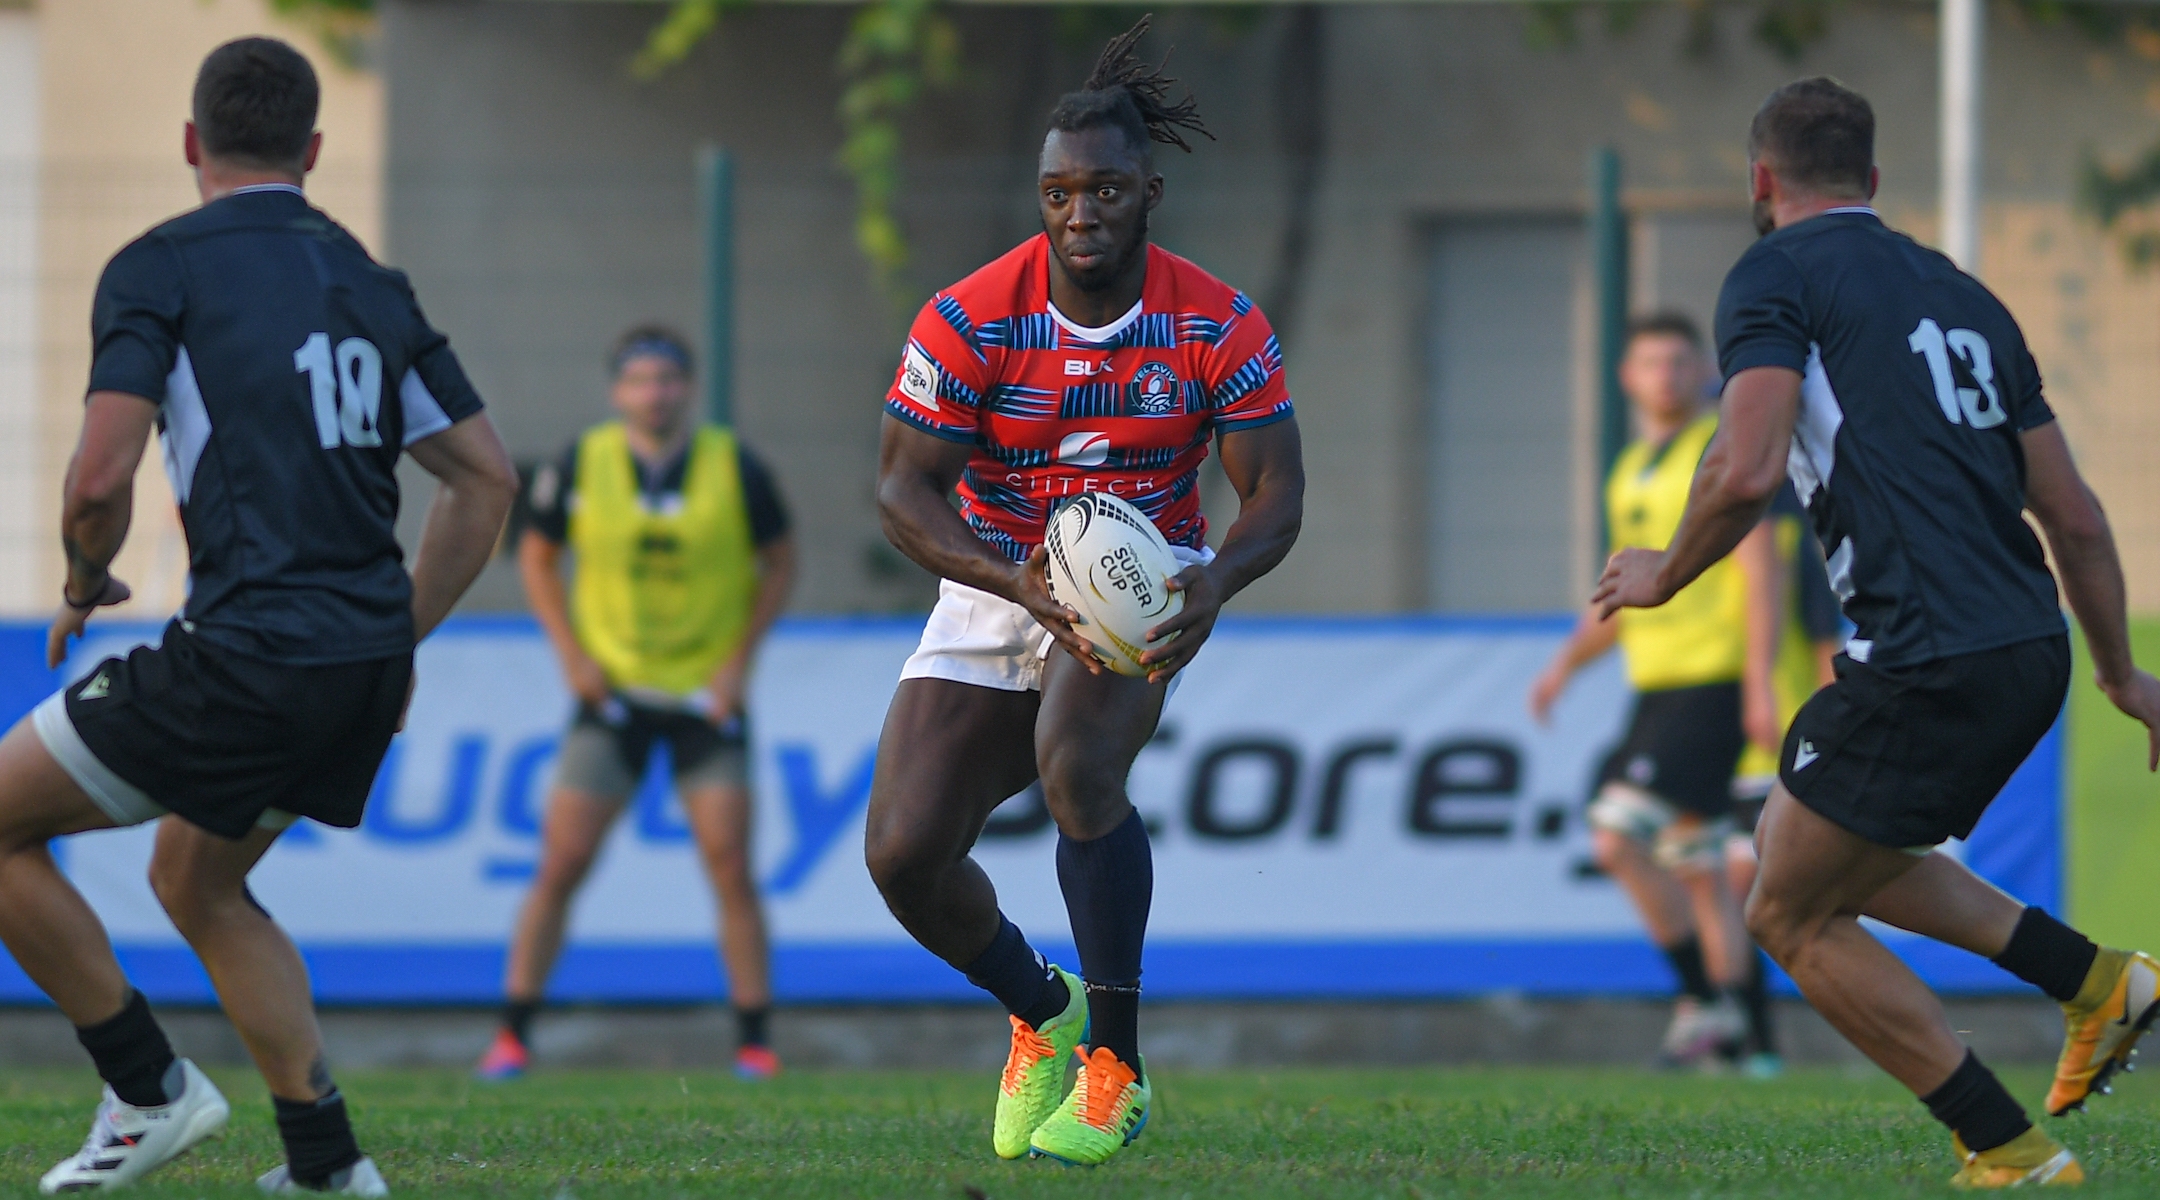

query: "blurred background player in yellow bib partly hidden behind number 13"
xmin=1529 ymin=313 xmax=1780 ymax=1066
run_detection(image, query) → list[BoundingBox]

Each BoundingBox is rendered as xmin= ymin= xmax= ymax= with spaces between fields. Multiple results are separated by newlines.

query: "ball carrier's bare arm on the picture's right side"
xmin=1140 ymin=417 xmax=1305 ymax=684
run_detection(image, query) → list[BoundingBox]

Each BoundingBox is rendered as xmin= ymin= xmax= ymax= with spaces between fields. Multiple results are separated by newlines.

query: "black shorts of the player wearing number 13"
xmin=1778 ymin=635 xmax=2069 ymax=850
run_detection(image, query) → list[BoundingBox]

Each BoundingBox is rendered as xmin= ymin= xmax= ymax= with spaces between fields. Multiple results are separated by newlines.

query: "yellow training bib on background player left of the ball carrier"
xmin=570 ymin=421 xmax=758 ymax=695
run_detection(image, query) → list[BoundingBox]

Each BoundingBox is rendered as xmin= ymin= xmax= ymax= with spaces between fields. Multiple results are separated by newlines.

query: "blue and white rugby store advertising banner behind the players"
xmin=0 ymin=617 xmax=2063 ymax=1004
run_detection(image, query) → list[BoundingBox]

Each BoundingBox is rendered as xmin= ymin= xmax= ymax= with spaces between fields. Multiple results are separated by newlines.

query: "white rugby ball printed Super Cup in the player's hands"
xmin=1043 ymin=492 xmax=1186 ymax=676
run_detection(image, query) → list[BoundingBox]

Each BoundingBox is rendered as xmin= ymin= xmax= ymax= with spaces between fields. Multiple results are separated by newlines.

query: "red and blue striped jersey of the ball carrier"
xmin=886 ymin=233 xmax=1292 ymax=561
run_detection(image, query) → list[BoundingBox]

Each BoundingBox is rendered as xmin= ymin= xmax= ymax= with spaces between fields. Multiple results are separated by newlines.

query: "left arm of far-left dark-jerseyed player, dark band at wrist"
xmin=45 ymin=391 xmax=158 ymax=667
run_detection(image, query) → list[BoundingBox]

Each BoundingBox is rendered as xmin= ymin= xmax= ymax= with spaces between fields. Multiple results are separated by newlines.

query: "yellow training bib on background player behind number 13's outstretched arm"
xmin=1605 ymin=412 xmax=1747 ymax=691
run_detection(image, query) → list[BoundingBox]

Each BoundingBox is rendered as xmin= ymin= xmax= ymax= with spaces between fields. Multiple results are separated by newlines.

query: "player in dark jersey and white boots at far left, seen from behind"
xmin=0 ymin=39 xmax=516 ymax=1196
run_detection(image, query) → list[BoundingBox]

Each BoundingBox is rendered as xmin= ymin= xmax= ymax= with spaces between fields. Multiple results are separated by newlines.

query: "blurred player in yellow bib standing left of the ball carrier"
xmin=477 ymin=326 xmax=795 ymax=1079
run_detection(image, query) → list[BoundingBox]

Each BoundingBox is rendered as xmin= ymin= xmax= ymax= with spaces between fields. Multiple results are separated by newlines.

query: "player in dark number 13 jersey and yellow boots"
xmin=1596 ymin=78 xmax=2160 ymax=1187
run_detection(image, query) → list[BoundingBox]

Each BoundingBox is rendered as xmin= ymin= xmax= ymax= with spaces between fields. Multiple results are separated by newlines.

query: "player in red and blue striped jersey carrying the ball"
xmin=866 ymin=19 xmax=1305 ymax=1163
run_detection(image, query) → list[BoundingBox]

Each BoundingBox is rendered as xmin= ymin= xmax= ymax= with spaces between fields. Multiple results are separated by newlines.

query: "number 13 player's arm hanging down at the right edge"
xmin=2020 ymin=421 xmax=2160 ymax=771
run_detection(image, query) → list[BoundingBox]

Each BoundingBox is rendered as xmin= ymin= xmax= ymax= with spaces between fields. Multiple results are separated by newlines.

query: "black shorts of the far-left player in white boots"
xmin=35 ymin=622 xmax=413 ymax=837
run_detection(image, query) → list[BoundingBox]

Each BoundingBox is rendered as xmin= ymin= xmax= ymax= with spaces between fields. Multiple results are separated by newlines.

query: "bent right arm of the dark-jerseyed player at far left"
xmin=408 ymin=412 xmax=518 ymax=641
